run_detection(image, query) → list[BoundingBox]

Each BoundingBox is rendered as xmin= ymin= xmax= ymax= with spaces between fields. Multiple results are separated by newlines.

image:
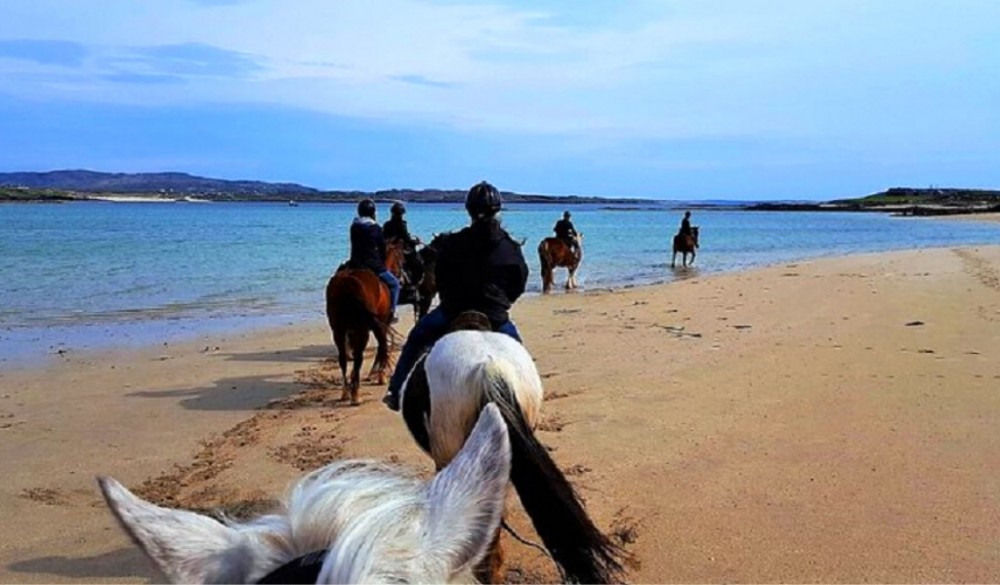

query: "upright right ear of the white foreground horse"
xmin=423 ymin=404 xmax=511 ymax=575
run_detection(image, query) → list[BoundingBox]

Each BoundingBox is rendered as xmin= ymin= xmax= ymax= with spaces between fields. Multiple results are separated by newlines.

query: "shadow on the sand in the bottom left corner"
xmin=7 ymin=547 xmax=156 ymax=583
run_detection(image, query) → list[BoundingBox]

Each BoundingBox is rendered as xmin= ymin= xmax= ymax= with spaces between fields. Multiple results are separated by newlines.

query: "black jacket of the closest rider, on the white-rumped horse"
xmin=435 ymin=219 xmax=528 ymax=326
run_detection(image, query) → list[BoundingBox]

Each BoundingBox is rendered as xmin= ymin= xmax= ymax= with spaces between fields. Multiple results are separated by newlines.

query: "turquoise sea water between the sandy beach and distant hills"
xmin=0 ymin=202 xmax=1000 ymax=360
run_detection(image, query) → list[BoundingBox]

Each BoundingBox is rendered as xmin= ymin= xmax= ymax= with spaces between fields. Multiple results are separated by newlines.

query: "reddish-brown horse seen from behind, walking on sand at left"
xmin=326 ymin=240 xmax=403 ymax=406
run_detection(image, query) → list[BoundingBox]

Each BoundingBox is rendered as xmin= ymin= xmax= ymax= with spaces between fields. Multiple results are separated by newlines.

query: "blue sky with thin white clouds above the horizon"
xmin=0 ymin=0 xmax=1000 ymax=199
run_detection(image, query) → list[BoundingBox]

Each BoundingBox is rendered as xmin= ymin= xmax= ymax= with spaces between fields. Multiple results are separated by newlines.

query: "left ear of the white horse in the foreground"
xmin=97 ymin=477 xmax=253 ymax=583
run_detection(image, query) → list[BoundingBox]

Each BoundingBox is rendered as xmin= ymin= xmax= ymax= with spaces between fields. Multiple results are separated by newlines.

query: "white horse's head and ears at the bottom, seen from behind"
xmin=97 ymin=405 xmax=511 ymax=583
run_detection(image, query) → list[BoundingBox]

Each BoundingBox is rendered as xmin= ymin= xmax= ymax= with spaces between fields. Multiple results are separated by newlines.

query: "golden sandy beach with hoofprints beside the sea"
xmin=0 ymin=247 xmax=1000 ymax=583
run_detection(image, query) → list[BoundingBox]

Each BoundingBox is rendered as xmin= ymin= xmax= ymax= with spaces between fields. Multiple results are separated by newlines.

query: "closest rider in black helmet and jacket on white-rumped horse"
xmin=383 ymin=181 xmax=528 ymax=410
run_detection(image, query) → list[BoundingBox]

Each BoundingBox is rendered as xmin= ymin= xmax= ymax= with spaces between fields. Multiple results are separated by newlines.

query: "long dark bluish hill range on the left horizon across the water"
xmin=0 ymin=170 xmax=656 ymax=205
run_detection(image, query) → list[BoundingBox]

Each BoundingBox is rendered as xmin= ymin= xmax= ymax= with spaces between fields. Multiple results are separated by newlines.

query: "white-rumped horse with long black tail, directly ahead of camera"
xmin=400 ymin=314 xmax=625 ymax=583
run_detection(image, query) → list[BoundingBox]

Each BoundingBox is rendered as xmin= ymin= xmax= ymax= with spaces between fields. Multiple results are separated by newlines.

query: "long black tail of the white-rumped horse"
xmin=477 ymin=360 xmax=625 ymax=583
